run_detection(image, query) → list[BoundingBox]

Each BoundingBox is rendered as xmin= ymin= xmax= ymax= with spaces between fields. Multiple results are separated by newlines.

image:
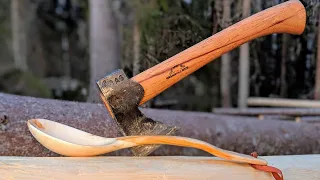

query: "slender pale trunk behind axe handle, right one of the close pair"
xmin=238 ymin=0 xmax=251 ymax=108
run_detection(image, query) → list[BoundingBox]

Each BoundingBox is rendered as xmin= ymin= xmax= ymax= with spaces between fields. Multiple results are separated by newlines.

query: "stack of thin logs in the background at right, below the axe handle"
xmin=213 ymin=97 xmax=320 ymax=123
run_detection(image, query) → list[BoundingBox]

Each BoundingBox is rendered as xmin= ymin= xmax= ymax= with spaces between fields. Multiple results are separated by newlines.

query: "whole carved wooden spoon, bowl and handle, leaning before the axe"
xmin=27 ymin=119 xmax=267 ymax=165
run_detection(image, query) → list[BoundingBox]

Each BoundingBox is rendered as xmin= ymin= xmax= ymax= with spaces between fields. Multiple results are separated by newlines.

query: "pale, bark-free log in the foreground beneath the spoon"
xmin=0 ymin=155 xmax=320 ymax=180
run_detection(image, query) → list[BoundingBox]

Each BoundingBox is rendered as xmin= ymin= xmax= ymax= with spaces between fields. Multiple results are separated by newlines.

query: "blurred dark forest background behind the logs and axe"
xmin=0 ymin=0 xmax=320 ymax=111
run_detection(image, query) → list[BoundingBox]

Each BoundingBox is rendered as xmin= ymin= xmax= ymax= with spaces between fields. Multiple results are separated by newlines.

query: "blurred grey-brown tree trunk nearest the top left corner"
xmin=11 ymin=0 xmax=28 ymax=71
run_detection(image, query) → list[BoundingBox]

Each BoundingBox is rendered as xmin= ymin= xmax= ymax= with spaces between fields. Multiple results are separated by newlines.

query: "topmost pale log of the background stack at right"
xmin=247 ymin=97 xmax=320 ymax=108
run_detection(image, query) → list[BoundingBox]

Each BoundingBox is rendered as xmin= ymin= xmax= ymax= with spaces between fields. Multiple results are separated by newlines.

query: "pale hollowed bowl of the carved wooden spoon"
xmin=27 ymin=119 xmax=132 ymax=157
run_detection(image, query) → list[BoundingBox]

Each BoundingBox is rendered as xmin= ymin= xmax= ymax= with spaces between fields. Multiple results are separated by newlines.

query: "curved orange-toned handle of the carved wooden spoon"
xmin=116 ymin=136 xmax=267 ymax=165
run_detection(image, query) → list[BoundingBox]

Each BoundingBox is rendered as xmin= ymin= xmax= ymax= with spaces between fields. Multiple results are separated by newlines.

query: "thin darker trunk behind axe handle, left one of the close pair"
xmin=220 ymin=0 xmax=231 ymax=107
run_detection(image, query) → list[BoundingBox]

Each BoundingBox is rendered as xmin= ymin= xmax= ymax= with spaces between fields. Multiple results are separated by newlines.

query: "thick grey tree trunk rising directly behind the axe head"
xmin=88 ymin=0 xmax=121 ymax=102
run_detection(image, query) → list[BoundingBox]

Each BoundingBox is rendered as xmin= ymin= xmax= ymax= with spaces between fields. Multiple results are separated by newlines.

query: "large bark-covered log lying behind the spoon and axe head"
xmin=0 ymin=93 xmax=320 ymax=156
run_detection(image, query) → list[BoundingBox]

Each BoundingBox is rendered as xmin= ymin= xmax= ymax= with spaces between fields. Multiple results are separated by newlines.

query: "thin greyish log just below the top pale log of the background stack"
xmin=212 ymin=108 xmax=320 ymax=116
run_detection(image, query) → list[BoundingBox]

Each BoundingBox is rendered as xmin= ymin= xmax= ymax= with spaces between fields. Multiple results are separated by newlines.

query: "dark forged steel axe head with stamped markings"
xmin=97 ymin=70 xmax=178 ymax=156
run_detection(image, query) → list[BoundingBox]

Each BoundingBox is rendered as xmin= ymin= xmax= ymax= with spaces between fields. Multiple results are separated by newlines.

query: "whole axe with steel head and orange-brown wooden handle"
xmin=97 ymin=0 xmax=306 ymax=156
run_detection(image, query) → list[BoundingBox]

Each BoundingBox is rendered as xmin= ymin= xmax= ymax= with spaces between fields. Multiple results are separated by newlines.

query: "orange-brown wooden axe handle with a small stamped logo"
xmin=132 ymin=0 xmax=306 ymax=104
